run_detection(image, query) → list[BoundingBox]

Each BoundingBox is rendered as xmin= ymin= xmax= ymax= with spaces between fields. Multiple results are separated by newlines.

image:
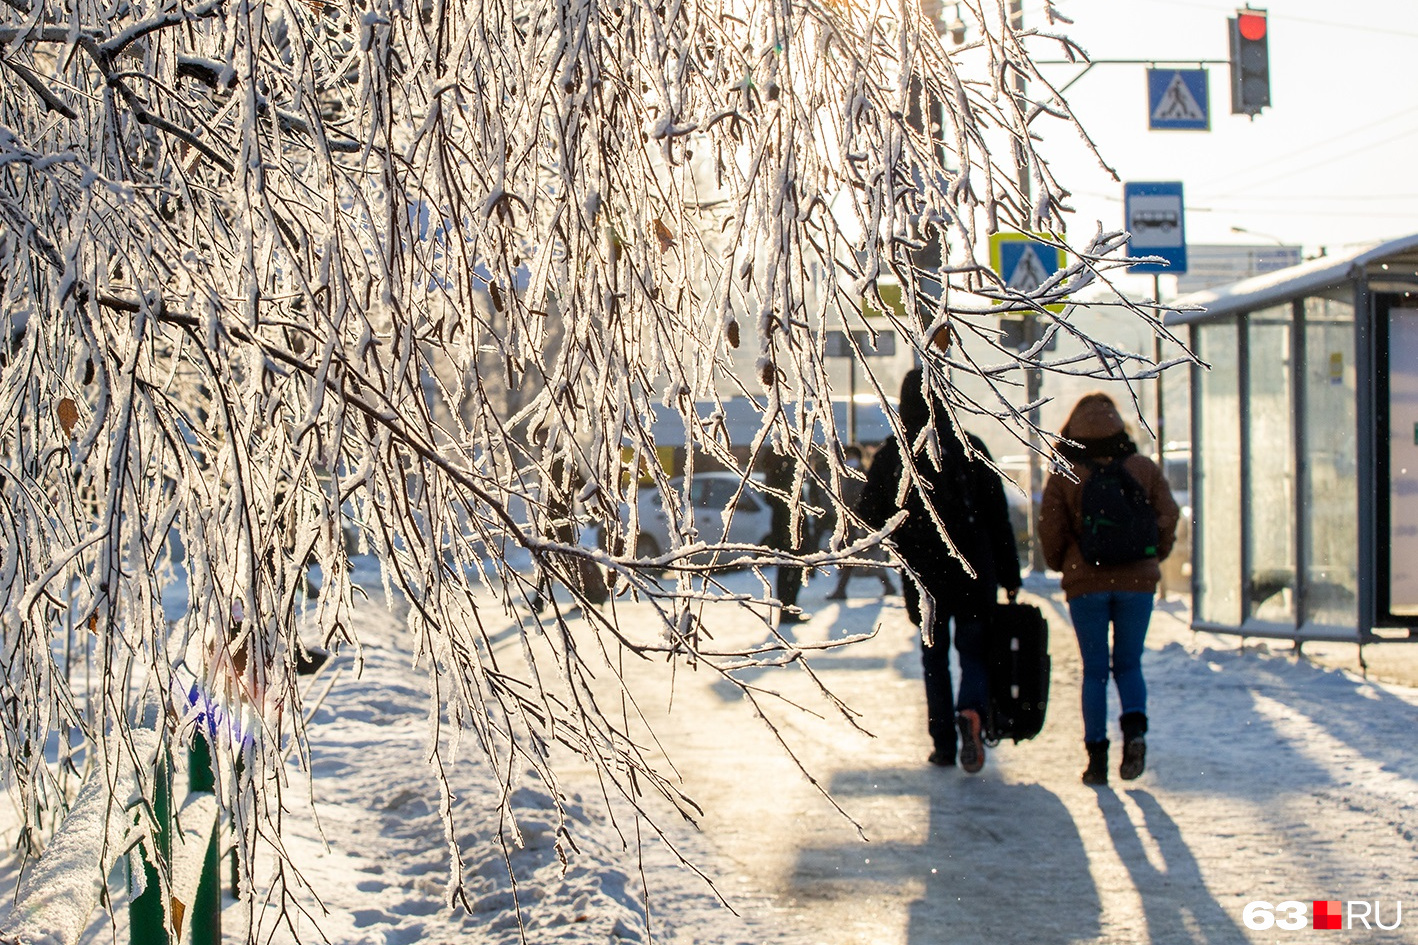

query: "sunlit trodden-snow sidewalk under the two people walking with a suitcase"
xmin=615 ymin=567 xmax=1418 ymax=945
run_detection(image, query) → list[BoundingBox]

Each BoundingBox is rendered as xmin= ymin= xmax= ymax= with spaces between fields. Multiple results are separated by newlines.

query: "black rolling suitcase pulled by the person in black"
xmin=984 ymin=603 xmax=1049 ymax=745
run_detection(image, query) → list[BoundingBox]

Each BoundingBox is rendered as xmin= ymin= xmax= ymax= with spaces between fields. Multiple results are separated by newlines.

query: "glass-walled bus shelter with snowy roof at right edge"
xmin=1166 ymin=236 xmax=1418 ymax=643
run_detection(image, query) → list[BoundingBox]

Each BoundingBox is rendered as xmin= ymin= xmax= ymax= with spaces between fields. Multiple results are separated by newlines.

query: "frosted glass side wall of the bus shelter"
xmin=1193 ymin=292 xmax=1358 ymax=629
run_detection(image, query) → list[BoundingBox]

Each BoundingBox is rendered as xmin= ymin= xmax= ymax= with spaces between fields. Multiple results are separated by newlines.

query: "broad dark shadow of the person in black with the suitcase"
xmin=788 ymin=768 xmax=1102 ymax=945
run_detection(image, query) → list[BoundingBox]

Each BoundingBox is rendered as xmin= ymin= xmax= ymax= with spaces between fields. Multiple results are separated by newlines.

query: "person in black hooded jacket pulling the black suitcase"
xmin=856 ymin=369 xmax=1021 ymax=773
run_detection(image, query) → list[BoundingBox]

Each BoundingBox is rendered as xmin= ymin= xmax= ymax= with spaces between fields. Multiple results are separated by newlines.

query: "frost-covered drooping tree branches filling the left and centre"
xmin=0 ymin=0 xmax=1185 ymax=935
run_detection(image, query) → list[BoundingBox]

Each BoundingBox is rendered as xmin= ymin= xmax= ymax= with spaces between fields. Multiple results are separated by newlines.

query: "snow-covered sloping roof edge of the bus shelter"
xmin=1164 ymin=234 xmax=1418 ymax=325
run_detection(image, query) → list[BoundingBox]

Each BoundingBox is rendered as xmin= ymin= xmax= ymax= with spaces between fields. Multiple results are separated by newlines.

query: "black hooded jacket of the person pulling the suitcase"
xmin=856 ymin=370 xmax=1021 ymax=617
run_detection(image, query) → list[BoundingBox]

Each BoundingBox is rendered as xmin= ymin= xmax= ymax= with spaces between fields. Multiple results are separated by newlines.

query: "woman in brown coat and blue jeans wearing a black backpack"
xmin=1039 ymin=392 xmax=1177 ymax=785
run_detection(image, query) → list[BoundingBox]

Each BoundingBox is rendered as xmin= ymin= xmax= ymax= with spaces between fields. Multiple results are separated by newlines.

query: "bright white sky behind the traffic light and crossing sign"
xmin=1026 ymin=0 xmax=1418 ymax=255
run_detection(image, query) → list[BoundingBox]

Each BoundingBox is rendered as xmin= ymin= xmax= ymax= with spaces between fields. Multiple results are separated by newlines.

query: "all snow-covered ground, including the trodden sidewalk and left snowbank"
xmin=0 ymin=561 xmax=1418 ymax=945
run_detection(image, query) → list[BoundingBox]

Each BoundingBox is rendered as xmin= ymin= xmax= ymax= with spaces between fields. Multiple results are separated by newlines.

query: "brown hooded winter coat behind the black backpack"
xmin=1039 ymin=394 xmax=1178 ymax=600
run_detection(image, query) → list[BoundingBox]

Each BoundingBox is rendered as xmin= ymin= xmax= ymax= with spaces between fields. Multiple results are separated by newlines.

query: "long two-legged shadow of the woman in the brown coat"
xmin=1098 ymin=788 xmax=1249 ymax=945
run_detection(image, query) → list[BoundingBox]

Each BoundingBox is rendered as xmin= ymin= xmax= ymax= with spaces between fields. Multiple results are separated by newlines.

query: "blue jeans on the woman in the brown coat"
xmin=1068 ymin=590 xmax=1153 ymax=742
